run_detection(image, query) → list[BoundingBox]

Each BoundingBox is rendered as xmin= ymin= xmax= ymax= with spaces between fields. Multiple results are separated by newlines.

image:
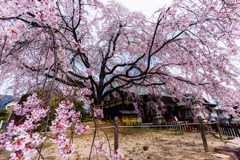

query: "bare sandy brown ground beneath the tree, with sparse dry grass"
xmin=0 ymin=122 xmax=224 ymax=160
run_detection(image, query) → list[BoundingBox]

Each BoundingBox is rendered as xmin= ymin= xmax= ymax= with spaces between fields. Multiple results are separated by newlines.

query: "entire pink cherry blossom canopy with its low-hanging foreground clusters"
xmin=0 ymin=0 xmax=240 ymax=159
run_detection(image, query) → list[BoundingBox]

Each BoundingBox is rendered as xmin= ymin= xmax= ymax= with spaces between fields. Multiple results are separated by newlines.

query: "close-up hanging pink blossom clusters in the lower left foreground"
xmin=0 ymin=86 xmax=124 ymax=159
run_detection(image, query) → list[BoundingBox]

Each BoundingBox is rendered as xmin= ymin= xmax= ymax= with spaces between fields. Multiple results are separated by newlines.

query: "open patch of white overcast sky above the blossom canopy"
xmin=101 ymin=0 xmax=172 ymax=18
